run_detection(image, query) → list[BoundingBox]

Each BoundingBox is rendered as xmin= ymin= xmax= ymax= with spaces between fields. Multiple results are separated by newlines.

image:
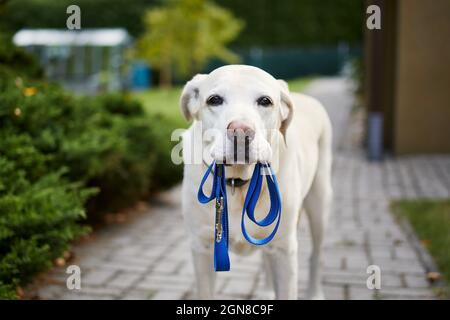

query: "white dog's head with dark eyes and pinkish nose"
xmin=180 ymin=65 xmax=293 ymax=178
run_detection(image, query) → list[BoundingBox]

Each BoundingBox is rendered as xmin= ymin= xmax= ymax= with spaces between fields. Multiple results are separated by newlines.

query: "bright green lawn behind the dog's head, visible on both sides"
xmin=132 ymin=77 xmax=314 ymax=128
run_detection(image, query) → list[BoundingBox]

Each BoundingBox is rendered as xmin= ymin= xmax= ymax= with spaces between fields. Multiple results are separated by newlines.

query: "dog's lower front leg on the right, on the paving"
xmin=263 ymin=242 xmax=298 ymax=300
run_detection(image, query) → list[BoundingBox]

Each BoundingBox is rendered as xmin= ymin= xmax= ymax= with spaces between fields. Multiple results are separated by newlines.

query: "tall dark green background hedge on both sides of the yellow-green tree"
xmin=0 ymin=0 xmax=364 ymax=47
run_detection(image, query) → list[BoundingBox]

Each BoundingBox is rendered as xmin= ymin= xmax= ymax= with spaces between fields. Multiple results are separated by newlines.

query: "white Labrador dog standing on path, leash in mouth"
xmin=180 ymin=65 xmax=332 ymax=299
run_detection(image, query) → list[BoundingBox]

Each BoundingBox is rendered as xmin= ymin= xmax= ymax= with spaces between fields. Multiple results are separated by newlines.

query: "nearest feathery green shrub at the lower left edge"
xmin=0 ymin=146 xmax=93 ymax=298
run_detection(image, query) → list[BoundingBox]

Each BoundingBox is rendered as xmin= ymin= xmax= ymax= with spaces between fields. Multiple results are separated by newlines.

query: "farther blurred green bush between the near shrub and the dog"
xmin=0 ymin=76 xmax=181 ymax=213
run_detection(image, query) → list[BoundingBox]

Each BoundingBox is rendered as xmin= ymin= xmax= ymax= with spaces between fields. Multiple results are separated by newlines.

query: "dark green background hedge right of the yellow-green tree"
xmin=216 ymin=0 xmax=364 ymax=47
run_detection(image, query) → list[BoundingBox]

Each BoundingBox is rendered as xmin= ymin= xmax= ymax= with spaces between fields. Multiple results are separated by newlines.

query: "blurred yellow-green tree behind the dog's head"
xmin=135 ymin=0 xmax=243 ymax=86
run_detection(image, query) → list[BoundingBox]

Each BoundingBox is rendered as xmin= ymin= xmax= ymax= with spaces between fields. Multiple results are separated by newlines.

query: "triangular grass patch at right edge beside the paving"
xmin=392 ymin=200 xmax=450 ymax=298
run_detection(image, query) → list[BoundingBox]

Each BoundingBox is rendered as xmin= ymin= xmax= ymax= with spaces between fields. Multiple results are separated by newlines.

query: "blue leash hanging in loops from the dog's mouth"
xmin=198 ymin=161 xmax=281 ymax=271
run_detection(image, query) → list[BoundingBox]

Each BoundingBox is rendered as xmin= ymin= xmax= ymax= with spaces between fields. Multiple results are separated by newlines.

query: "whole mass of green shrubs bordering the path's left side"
xmin=0 ymin=45 xmax=181 ymax=298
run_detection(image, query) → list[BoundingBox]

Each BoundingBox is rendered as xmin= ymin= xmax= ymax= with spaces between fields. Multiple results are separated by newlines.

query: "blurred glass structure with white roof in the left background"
xmin=13 ymin=28 xmax=131 ymax=93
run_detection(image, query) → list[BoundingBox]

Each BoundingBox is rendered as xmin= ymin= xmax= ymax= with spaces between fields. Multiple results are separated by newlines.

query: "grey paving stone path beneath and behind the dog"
xmin=30 ymin=78 xmax=450 ymax=299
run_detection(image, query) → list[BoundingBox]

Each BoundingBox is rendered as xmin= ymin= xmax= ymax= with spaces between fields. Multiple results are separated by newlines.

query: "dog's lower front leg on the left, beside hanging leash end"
xmin=192 ymin=247 xmax=216 ymax=300
